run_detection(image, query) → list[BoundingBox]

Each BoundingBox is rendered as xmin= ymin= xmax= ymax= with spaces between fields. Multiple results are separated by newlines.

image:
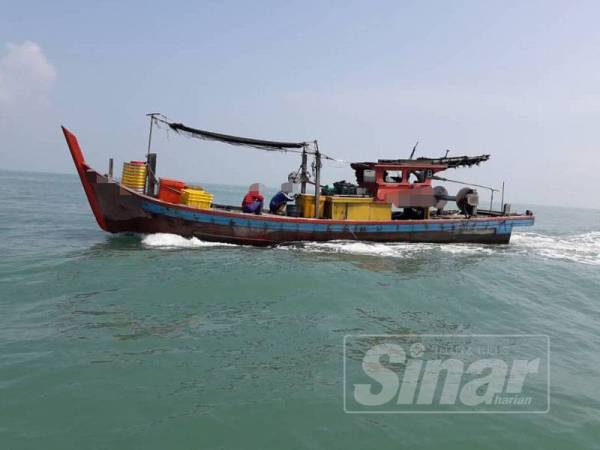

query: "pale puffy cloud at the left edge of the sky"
xmin=0 ymin=41 xmax=56 ymax=108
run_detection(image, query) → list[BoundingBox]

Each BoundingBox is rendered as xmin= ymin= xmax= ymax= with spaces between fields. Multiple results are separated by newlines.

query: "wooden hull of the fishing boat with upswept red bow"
xmin=63 ymin=128 xmax=534 ymax=246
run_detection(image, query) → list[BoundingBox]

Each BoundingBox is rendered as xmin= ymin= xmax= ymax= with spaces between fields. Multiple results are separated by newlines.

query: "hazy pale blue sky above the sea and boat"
xmin=0 ymin=0 xmax=600 ymax=208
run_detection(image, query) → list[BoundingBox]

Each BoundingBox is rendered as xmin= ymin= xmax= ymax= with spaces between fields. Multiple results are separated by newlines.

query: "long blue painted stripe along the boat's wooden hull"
xmin=142 ymin=201 xmax=533 ymax=234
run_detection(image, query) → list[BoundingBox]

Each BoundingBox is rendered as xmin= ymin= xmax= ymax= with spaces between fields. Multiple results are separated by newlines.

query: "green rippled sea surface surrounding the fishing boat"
xmin=0 ymin=171 xmax=600 ymax=450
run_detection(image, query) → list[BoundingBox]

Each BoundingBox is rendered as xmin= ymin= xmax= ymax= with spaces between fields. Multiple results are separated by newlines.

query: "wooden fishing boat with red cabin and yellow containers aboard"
xmin=62 ymin=113 xmax=534 ymax=246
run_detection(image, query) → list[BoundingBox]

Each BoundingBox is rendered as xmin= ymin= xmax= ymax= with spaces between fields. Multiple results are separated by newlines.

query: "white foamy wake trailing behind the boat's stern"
xmin=510 ymin=231 xmax=600 ymax=265
